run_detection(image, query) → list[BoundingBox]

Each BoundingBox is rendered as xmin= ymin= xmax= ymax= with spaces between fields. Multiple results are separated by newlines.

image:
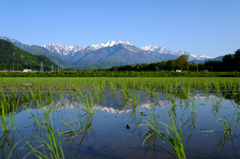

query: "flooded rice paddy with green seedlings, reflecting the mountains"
xmin=0 ymin=78 xmax=240 ymax=159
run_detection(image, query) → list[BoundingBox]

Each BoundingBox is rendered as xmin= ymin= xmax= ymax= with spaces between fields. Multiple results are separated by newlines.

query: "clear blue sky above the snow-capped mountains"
xmin=0 ymin=0 xmax=240 ymax=56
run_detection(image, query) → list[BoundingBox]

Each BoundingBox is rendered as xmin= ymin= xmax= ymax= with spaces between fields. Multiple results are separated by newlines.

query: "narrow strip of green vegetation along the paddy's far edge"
xmin=0 ymin=71 xmax=240 ymax=77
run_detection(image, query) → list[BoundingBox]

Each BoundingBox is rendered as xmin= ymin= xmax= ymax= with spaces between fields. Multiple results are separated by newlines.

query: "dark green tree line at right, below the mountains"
xmin=109 ymin=49 xmax=240 ymax=71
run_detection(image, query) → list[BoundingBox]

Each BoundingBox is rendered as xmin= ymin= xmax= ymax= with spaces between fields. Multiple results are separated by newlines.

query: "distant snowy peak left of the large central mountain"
xmin=42 ymin=44 xmax=84 ymax=59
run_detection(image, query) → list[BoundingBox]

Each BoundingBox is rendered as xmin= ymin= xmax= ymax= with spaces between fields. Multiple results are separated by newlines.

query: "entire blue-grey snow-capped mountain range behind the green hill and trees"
xmin=0 ymin=36 xmax=218 ymax=69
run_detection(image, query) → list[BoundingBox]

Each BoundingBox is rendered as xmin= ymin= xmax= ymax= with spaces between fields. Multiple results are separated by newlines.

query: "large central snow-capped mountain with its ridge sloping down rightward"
xmin=62 ymin=40 xmax=214 ymax=68
